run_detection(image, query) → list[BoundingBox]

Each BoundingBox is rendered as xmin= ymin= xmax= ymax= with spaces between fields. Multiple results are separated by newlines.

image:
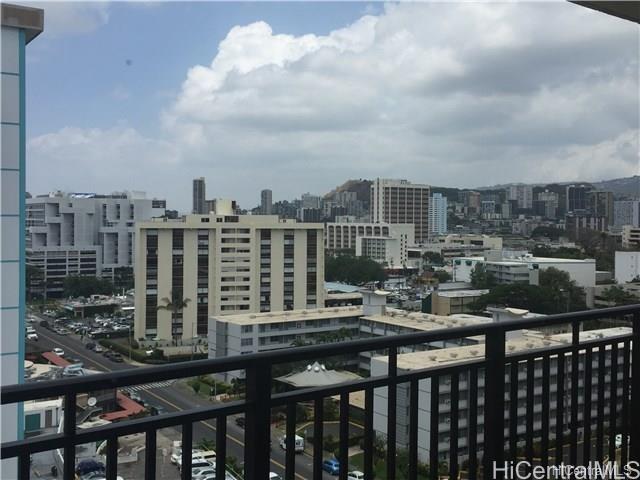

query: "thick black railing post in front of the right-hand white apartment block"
xmin=484 ymin=330 xmax=505 ymax=480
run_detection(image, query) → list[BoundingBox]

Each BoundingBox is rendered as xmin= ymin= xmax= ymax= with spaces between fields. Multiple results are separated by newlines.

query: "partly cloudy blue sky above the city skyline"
xmin=26 ymin=2 xmax=640 ymax=211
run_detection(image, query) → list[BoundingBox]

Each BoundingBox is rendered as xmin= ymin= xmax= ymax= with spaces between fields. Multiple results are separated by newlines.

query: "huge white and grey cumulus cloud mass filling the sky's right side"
xmin=27 ymin=2 xmax=639 ymax=208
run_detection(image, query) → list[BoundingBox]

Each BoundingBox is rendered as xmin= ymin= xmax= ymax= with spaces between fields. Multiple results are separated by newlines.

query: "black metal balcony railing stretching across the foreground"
xmin=2 ymin=305 xmax=640 ymax=480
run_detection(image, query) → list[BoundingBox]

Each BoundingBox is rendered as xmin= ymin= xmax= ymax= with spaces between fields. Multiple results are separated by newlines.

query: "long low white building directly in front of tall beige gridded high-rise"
xmin=324 ymin=217 xmax=415 ymax=252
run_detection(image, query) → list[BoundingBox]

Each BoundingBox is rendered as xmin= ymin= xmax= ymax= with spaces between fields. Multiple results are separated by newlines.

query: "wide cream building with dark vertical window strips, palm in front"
xmin=135 ymin=212 xmax=324 ymax=340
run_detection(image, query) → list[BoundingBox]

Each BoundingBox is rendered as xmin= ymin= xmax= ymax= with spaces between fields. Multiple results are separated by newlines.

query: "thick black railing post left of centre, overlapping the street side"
xmin=244 ymin=360 xmax=271 ymax=480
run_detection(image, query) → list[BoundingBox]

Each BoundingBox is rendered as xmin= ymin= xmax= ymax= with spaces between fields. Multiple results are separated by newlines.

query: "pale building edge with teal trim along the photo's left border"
xmin=0 ymin=3 xmax=44 ymax=478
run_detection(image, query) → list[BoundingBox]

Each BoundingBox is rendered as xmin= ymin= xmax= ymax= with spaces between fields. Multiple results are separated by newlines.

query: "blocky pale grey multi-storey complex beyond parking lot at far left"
xmin=26 ymin=192 xmax=166 ymax=296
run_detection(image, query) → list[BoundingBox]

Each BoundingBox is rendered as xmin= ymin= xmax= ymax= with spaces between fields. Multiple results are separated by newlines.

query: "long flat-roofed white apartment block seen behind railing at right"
xmin=371 ymin=327 xmax=631 ymax=463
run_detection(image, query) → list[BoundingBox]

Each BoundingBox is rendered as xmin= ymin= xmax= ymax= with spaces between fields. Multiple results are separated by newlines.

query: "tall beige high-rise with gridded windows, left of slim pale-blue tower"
xmin=370 ymin=178 xmax=431 ymax=243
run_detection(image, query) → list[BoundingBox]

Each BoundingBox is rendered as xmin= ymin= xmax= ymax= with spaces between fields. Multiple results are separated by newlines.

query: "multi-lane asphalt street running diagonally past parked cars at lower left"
xmin=33 ymin=317 xmax=335 ymax=480
